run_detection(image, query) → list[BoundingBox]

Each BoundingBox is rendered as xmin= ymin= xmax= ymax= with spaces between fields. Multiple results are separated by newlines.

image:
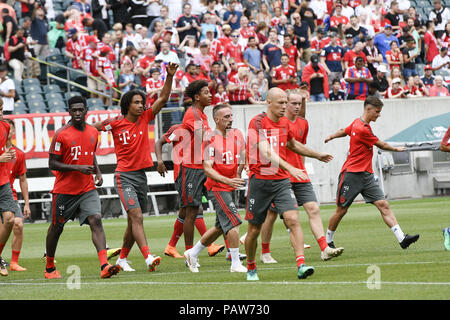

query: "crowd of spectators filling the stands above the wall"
xmin=0 ymin=0 xmax=450 ymax=115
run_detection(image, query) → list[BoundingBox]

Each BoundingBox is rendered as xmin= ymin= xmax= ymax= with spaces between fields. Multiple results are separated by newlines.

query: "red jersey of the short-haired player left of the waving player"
xmin=48 ymin=122 xmax=98 ymax=195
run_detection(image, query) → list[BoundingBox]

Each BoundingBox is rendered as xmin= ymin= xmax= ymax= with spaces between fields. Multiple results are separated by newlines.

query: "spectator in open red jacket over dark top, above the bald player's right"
xmin=302 ymin=54 xmax=330 ymax=101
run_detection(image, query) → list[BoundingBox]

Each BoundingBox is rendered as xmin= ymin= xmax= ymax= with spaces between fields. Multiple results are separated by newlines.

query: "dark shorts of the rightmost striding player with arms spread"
xmin=336 ymin=171 xmax=385 ymax=207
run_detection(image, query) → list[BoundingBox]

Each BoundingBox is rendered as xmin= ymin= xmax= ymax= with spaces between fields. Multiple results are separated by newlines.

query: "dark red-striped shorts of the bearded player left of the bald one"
xmin=209 ymin=191 xmax=242 ymax=234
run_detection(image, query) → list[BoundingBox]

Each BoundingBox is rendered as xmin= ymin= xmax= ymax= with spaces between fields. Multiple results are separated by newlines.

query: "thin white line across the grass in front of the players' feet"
xmin=0 ymin=280 xmax=450 ymax=286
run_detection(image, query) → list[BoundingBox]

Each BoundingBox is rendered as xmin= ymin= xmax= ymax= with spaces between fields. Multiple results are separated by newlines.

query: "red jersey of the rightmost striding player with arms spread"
xmin=341 ymin=118 xmax=379 ymax=173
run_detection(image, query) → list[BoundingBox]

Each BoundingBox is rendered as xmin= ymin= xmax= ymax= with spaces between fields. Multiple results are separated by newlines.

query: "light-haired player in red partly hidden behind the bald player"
xmin=261 ymin=90 xmax=344 ymax=263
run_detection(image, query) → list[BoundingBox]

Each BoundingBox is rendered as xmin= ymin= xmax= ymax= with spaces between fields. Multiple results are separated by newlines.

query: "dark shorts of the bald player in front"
xmin=245 ymin=176 xmax=298 ymax=225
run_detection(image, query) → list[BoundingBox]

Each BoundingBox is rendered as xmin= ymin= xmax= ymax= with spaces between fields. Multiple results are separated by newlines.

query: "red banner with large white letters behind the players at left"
xmin=5 ymin=110 xmax=155 ymax=159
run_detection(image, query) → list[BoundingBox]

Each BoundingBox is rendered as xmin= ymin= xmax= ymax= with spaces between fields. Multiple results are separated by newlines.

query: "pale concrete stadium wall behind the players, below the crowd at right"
xmin=205 ymin=97 xmax=450 ymax=202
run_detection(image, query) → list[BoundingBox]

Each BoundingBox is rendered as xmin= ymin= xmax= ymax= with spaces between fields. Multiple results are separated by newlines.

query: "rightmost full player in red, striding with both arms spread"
xmin=325 ymin=96 xmax=419 ymax=249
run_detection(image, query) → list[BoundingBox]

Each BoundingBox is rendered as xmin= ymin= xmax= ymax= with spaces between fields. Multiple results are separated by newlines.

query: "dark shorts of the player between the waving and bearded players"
xmin=175 ymin=166 xmax=206 ymax=208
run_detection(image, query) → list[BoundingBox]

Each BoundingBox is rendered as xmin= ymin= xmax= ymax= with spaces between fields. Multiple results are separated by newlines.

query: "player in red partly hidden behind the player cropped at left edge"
xmin=1 ymin=119 xmax=31 ymax=271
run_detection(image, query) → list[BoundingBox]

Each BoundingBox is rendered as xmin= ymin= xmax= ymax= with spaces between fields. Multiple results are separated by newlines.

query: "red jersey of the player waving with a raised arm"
xmin=102 ymin=108 xmax=155 ymax=172
